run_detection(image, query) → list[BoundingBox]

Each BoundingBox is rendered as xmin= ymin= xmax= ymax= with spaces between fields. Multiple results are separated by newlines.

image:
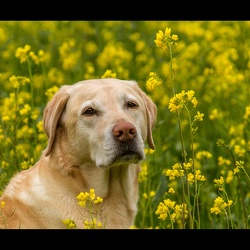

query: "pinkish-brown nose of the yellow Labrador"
xmin=113 ymin=122 xmax=136 ymax=141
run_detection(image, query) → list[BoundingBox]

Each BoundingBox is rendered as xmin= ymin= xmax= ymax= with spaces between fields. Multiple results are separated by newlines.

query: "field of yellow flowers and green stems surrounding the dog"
xmin=0 ymin=21 xmax=250 ymax=229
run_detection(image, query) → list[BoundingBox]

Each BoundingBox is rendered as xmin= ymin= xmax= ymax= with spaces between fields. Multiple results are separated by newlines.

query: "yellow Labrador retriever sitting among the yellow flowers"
xmin=0 ymin=78 xmax=157 ymax=229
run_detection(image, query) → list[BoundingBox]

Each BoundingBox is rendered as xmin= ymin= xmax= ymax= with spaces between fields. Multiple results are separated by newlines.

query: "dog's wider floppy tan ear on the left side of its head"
xmin=43 ymin=85 xmax=70 ymax=156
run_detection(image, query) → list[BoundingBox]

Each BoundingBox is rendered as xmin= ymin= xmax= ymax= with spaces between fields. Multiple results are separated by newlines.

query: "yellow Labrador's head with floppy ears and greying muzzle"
xmin=43 ymin=78 xmax=157 ymax=167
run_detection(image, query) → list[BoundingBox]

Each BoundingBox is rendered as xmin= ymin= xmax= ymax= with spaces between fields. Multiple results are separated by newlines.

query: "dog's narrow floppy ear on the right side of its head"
xmin=141 ymin=91 xmax=157 ymax=149
